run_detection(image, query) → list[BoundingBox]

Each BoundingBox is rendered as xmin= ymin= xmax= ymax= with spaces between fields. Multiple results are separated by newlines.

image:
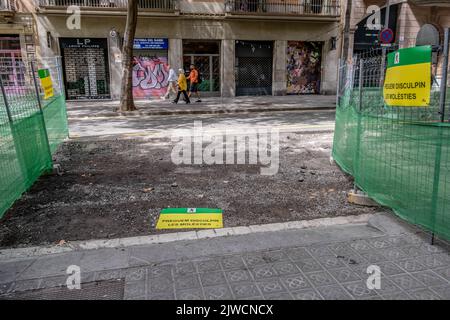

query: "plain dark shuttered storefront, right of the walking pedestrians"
xmin=235 ymin=40 xmax=273 ymax=96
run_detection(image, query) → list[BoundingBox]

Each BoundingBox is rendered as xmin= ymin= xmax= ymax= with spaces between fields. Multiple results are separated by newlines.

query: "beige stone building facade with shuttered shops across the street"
xmin=31 ymin=0 xmax=341 ymax=99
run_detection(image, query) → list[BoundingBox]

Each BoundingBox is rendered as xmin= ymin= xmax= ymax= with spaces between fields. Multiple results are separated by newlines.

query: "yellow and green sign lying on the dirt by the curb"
xmin=156 ymin=208 xmax=223 ymax=229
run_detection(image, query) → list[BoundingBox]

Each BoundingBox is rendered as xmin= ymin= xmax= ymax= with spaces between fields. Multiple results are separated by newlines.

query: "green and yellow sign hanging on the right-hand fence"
xmin=383 ymin=46 xmax=431 ymax=107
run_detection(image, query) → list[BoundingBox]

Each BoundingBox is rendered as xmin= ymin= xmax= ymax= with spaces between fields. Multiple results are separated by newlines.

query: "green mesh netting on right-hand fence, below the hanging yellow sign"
xmin=333 ymin=88 xmax=450 ymax=239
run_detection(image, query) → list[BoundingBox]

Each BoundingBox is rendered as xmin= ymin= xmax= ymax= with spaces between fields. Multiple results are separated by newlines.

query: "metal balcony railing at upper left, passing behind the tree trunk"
xmin=39 ymin=0 xmax=176 ymax=11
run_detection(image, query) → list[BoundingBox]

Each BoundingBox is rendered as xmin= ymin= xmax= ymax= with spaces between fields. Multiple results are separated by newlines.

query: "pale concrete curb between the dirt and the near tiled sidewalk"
xmin=0 ymin=214 xmax=373 ymax=262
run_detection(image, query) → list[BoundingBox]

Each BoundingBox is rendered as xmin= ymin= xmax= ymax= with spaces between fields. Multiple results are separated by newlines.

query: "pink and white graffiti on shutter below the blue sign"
xmin=132 ymin=57 xmax=169 ymax=98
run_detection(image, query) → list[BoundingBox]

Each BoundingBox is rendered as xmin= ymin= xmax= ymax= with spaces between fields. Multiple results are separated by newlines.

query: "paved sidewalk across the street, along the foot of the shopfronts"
xmin=67 ymin=95 xmax=336 ymax=119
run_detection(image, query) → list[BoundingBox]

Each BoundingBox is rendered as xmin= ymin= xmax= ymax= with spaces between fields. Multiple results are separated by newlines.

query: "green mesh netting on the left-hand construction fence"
xmin=0 ymin=90 xmax=68 ymax=218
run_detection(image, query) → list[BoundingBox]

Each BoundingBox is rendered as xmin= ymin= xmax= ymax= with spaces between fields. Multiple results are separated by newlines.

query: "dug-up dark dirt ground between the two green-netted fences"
xmin=0 ymin=133 xmax=379 ymax=248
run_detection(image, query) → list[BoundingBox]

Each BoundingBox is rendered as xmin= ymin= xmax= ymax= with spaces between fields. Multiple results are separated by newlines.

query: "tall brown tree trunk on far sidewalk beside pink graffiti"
xmin=120 ymin=0 xmax=138 ymax=111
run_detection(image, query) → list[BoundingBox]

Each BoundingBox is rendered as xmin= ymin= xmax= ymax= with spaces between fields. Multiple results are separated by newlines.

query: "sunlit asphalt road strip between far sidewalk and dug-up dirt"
xmin=69 ymin=110 xmax=335 ymax=138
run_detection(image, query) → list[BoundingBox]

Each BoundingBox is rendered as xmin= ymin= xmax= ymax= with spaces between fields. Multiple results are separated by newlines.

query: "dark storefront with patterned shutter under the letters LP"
xmin=59 ymin=38 xmax=111 ymax=100
